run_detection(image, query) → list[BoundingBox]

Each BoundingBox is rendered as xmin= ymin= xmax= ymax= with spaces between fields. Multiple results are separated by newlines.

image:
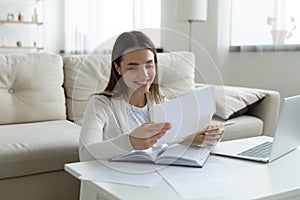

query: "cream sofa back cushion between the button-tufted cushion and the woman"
xmin=63 ymin=54 xmax=110 ymax=124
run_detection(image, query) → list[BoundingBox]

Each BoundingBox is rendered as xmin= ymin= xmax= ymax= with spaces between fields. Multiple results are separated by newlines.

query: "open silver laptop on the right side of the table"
xmin=211 ymin=95 xmax=300 ymax=163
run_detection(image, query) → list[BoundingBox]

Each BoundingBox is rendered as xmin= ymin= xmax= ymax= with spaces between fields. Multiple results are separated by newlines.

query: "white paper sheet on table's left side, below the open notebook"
xmin=79 ymin=162 xmax=162 ymax=187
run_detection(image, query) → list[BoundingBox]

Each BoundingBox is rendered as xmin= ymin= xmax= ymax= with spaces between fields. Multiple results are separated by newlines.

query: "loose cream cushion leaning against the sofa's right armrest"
xmin=215 ymin=86 xmax=266 ymax=120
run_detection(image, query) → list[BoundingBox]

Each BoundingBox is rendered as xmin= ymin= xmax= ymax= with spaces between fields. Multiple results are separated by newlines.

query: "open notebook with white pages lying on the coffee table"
xmin=111 ymin=144 xmax=211 ymax=167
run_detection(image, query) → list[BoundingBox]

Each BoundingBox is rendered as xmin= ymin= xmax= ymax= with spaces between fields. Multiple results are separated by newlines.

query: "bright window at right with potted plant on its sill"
xmin=231 ymin=0 xmax=300 ymax=46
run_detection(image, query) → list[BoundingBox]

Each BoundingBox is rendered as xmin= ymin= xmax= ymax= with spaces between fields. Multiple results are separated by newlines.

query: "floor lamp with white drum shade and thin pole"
xmin=176 ymin=0 xmax=207 ymax=51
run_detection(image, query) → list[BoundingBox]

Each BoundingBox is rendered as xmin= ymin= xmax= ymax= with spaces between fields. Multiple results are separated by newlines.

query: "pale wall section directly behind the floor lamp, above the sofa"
xmin=162 ymin=0 xmax=223 ymax=84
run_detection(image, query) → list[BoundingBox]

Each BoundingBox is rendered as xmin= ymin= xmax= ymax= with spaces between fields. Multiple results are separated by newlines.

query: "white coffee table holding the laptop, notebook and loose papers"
xmin=65 ymin=148 xmax=300 ymax=200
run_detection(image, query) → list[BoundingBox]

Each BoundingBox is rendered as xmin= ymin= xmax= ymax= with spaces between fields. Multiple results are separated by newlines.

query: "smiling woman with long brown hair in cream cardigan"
xmin=80 ymin=31 xmax=222 ymax=161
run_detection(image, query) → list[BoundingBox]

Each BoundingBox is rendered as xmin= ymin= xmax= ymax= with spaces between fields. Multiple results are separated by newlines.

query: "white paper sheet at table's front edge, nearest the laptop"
xmin=157 ymin=163 xmax=244 ymax=199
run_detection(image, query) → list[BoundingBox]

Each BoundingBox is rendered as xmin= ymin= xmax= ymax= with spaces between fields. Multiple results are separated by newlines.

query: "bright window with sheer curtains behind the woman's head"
xmin=65 ymin=0 xmax=161 ymax=53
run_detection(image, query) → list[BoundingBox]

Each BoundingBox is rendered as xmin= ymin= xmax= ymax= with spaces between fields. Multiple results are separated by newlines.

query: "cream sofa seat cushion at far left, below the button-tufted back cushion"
xmin=0 ymin=120 xmax=80 ymax=179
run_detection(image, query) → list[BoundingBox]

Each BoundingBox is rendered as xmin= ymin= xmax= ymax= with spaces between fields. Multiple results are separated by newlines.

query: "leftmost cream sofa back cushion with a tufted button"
xmin=0 ymin=53 xmax=66 ymax=124
